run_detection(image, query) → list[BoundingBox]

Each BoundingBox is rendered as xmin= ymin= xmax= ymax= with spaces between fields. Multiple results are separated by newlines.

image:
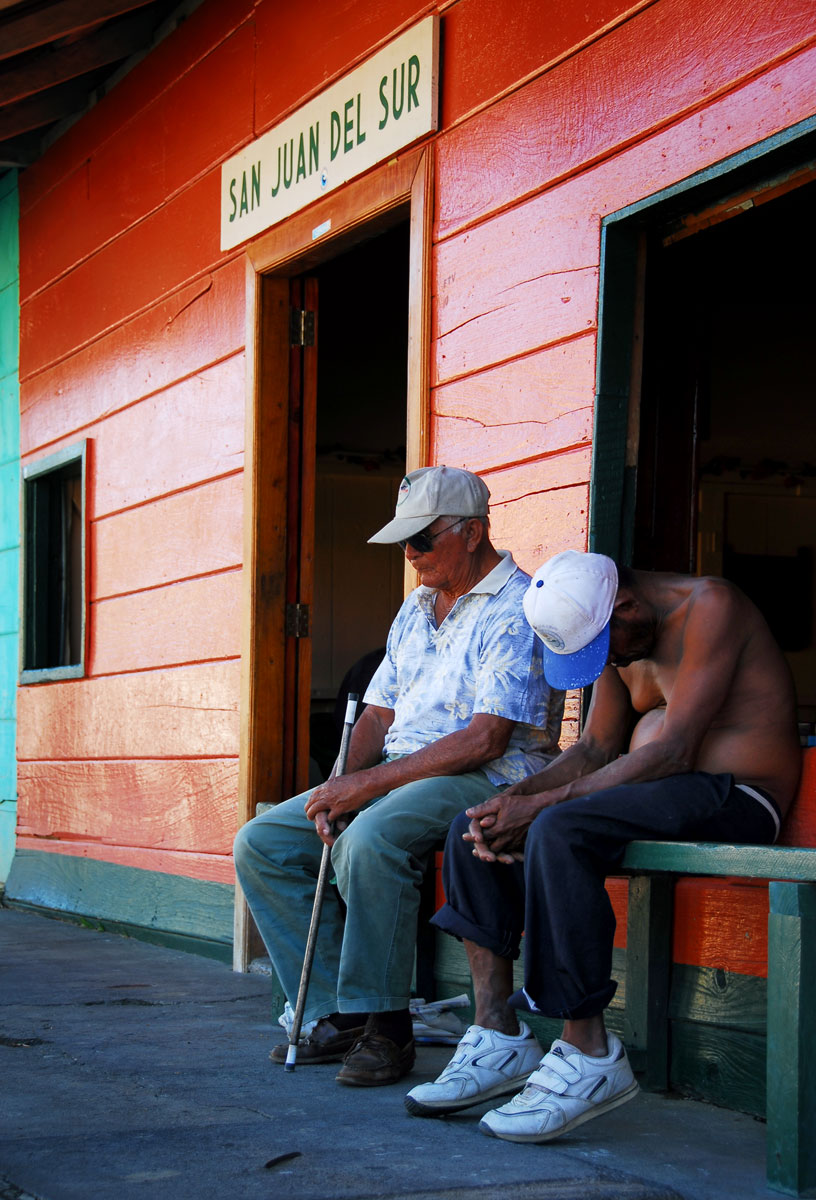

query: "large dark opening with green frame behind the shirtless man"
xmin=589 ymin=127 xmax=816 ymax=733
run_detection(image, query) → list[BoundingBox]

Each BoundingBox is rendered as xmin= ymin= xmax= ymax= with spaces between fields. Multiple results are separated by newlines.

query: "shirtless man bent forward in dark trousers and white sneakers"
xmin=406 ymin=551 xmax=800 ymax=1142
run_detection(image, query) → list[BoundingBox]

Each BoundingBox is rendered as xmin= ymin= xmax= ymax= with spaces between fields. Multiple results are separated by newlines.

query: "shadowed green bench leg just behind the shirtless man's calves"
xmin=624 ymin=875 xmax=674 ymax=1092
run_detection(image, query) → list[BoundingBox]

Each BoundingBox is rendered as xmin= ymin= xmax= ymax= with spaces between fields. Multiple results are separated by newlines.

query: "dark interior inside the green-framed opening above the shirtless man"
xmin=632 ymin=173 xmax=816 ymax=733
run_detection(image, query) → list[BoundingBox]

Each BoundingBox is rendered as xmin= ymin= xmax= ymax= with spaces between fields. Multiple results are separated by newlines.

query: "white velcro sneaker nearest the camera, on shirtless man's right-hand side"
xmin=479 ymin=1033 xmax=638 ymax=1141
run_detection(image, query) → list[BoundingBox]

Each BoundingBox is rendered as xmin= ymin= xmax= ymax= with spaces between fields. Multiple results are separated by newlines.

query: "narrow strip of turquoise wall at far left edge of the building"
xmin=0 ymin=172 xmax=20 ymax=883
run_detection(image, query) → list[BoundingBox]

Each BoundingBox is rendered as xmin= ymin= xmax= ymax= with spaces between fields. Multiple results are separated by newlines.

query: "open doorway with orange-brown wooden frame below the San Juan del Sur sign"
xmin=233 ymin=146 xmax=433 ymax=971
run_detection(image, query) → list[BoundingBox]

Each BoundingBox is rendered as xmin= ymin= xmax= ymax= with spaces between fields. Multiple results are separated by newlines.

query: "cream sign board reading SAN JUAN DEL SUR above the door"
xmin=221 ymin=17 xmax=439 ymax=250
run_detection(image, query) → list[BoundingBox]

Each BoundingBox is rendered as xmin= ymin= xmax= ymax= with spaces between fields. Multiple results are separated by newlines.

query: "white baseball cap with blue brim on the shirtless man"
xmin=523 ymin=550 xmax=618 ymax=690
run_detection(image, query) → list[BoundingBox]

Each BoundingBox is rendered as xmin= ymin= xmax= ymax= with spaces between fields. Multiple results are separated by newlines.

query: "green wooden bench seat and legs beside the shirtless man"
xmin=622 ymin=841 xmax=816 ymax=1195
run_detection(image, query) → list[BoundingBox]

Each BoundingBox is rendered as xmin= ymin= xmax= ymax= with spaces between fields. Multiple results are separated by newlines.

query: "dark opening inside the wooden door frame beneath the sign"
xmin=308 ymin=222 xmax=409 ymax=785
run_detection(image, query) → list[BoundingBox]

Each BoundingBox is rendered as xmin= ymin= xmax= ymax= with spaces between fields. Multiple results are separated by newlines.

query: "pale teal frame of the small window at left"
xmin=19 ymin=438 xmax=90 ymax=686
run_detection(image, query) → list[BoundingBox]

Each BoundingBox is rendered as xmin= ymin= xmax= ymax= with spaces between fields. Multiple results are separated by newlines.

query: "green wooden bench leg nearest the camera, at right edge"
xmin=767 ymin=882 xmax=816 ymax=1196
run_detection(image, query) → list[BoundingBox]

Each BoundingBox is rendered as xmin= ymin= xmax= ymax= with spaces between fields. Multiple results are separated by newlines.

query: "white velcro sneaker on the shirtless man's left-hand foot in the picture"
xmin=406 ymin=1021 xmax=541 ymax=1117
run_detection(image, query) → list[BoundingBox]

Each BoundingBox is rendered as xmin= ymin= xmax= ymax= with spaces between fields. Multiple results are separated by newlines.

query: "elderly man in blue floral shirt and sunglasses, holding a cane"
xmin=235 ymin=467 xmax=564 ymax=1086
